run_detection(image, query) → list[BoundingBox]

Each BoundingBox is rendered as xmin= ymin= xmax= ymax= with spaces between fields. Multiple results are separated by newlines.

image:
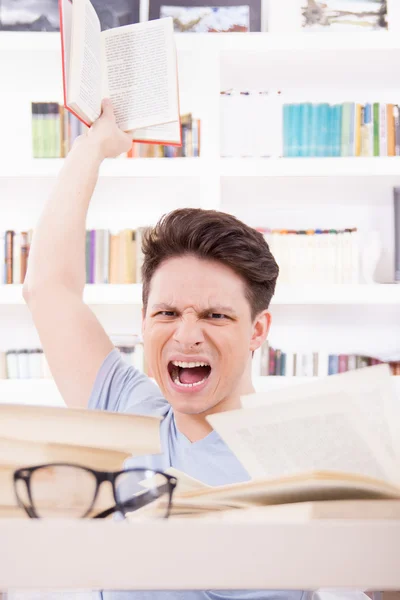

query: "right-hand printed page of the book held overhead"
xmin=101 ymin=18 xmax=179 ymax=131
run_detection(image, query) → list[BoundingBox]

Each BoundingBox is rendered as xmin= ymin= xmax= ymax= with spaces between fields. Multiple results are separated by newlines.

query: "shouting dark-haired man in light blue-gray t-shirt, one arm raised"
xmin=24 ymin=101 xmax=302 ymax=600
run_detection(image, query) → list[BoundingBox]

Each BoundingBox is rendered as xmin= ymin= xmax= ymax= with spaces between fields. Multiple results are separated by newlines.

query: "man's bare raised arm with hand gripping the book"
xmin=23 ymin=100 xmax=132 ymax=407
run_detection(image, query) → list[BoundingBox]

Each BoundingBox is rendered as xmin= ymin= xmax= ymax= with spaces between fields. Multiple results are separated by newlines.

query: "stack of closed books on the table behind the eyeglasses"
xmin=0 ymin=404 xmax=161 ymax=517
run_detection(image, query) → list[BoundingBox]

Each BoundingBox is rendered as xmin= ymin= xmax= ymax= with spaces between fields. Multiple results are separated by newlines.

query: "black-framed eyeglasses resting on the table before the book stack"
xmin=14 ymin=463 xmax=177 ymax=519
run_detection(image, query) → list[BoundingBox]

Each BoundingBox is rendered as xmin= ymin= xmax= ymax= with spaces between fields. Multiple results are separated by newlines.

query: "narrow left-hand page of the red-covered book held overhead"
xmin=67 ymin=0 xmax=102 ymax=124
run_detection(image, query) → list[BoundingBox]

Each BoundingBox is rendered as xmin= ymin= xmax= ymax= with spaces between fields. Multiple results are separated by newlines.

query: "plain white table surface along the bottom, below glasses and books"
xmin=0 ymin=518 xmax=400 ymax=590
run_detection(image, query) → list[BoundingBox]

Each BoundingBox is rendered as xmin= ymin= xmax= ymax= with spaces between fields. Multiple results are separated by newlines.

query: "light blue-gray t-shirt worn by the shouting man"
xmin=89 ymin=349 xmax=303 ymax=600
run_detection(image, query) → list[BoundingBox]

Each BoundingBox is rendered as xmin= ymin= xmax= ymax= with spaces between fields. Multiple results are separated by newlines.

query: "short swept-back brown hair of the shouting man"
xmin=142 ymin=208 xmax=279 ymax=319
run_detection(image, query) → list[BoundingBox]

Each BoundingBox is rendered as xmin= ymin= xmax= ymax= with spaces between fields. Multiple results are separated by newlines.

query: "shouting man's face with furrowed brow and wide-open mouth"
xmin=143 ymin=256 xmax=269 ymax=414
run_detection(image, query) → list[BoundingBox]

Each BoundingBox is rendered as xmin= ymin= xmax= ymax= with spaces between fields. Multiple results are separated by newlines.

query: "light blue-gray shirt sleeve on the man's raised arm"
xmin=88 ymin=348 xmax=170 ymax=417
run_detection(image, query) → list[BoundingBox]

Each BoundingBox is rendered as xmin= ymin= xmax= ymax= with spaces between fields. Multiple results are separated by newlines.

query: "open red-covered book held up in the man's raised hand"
xmin=59 ymin=0 xmax=182 ymax=146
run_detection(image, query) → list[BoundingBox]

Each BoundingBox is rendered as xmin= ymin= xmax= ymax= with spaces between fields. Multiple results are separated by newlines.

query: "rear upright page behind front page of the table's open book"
xmin=241 ymin=365 xmax=400 ymax=464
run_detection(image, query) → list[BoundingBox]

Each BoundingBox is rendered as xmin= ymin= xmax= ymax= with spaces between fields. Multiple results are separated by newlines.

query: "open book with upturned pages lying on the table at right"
xmin=128 ymin=365 xmax=400 ymax=517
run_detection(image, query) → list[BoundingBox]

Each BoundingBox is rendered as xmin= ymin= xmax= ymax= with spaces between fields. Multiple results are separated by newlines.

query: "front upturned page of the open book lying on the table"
xmin=207 ymin=390 xmax=399 ymax=484
